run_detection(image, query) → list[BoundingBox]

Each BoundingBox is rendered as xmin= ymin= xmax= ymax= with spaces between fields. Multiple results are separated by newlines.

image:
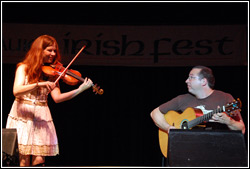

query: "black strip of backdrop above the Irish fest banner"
xmin=3 ymin=2 xmax=248 ymax=25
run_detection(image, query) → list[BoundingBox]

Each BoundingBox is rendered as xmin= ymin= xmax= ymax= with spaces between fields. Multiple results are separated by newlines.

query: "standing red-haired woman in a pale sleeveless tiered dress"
xmin=6 ymin=35 xmax=93 ymax=166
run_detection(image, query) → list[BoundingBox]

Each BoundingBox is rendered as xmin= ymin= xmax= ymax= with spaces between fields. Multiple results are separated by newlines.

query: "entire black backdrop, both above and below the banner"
xmin=2 ymin=3 xmax=249 ymax=167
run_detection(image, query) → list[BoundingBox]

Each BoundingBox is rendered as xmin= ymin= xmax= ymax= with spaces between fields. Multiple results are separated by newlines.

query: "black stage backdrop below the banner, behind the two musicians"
xmin=2 ymin=64 xmax=248 ymax=166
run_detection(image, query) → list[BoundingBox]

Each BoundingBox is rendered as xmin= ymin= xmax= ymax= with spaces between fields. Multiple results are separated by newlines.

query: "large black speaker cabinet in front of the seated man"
xmin=168 ymin=129 xmax=248 ymax=167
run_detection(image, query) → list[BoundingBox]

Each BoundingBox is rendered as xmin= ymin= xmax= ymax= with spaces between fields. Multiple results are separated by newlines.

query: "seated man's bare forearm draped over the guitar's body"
xmin=150 ymin=107 xmax=175 ymax=133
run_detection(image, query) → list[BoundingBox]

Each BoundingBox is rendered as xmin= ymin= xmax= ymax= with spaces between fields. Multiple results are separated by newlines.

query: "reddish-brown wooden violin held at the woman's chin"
xmin=42 ymin=62 xmax=104 ymax=95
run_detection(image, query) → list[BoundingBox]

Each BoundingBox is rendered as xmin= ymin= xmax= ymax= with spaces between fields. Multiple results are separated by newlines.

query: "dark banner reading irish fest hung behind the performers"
xmin=2 ymin=23 xmax=247 ymax=66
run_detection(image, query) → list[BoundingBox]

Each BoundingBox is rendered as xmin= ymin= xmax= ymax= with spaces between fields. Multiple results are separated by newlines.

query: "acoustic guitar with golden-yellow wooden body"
xmin=159 ymin=98 xmax=242 ymax=158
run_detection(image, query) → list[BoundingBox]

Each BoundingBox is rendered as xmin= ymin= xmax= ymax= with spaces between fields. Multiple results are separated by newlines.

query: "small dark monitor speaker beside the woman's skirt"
xmin=2 ymin=128 xmax=19 ymax=166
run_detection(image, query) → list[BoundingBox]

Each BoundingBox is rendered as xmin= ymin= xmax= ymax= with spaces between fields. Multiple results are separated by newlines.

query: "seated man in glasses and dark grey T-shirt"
xmin=150 ymin=66 xmax=245 ymax=157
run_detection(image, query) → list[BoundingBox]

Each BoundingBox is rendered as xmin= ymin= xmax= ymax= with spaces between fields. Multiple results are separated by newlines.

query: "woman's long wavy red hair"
xmin=17 ymin=35 xmax=61 ymax=83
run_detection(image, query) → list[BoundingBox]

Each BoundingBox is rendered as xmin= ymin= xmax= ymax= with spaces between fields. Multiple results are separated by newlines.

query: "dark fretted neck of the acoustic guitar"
xmin=188 ymin=106 xmax=225 ymax=129
